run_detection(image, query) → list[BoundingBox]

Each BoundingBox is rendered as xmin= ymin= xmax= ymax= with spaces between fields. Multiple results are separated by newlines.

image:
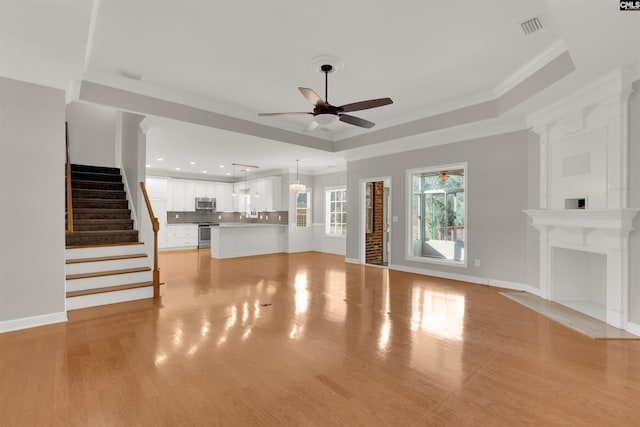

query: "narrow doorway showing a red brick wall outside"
xmin=361 ymin=177 xmax=391 ymax=267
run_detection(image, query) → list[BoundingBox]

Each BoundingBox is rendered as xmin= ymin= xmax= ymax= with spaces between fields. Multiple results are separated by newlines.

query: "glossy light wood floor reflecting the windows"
xmin=0 ymin=250 xmax=640 ymax=426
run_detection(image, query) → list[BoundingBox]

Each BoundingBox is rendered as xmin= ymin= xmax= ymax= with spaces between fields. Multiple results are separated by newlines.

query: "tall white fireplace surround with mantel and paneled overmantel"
xmin=526 ymin=68 xmax=638 ymax=330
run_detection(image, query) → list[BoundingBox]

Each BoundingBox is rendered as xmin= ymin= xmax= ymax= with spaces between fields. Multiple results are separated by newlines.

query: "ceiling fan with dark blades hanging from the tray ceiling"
xmin=258 ymin=64 xmax=393 ymax=132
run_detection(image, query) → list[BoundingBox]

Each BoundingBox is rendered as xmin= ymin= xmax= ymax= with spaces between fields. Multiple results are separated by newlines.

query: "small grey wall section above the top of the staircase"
xmin=66 ymin=102 xmax=119 ymax=167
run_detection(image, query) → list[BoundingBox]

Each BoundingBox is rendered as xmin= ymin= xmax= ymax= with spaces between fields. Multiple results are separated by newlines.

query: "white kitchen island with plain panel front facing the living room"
xmin=211 ymin=223 xmax=288 ymax=259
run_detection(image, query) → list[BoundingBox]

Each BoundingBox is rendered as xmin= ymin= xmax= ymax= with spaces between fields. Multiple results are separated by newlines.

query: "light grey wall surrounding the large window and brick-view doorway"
xmin=347 ymin=131 xmax=537 ymax=286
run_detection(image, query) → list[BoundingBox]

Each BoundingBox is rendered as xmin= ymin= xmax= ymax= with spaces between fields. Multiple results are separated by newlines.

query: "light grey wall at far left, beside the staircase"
xmin=0 ymin=78 xmax=66 ymax=332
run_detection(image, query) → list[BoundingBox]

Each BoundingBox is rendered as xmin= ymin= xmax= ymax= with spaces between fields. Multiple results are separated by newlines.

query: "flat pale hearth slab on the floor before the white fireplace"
xmin=501 ymin=292 xmax=640 ymax=339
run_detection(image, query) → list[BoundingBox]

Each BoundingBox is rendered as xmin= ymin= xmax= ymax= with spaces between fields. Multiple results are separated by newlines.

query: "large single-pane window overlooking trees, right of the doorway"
xmin=408 ymin=165 xmax=466 ymax=265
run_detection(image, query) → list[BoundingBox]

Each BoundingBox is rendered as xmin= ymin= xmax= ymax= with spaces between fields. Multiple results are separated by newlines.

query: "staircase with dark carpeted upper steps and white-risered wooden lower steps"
xmin=65 ymin=164 xmax=160 ymax=310
